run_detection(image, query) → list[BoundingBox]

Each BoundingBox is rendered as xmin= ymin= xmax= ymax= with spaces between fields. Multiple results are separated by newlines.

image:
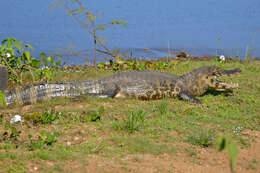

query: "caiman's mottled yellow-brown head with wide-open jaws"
xmin=181 ymin=66 xmax=241 ymax=102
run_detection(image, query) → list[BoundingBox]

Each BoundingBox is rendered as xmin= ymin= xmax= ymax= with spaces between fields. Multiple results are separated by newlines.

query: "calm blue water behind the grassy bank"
xmin=0 ymin=0 xmax=260 ymax=64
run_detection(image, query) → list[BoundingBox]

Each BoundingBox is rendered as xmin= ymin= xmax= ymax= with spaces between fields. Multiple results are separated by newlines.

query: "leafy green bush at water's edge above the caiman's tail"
xmin=0 ymin=38 xmax=61 ymax=83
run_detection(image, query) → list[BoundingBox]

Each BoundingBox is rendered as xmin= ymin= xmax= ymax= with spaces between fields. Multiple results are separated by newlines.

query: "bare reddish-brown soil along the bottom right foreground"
xmin=58 ymin=131 xmax=260 ymax=173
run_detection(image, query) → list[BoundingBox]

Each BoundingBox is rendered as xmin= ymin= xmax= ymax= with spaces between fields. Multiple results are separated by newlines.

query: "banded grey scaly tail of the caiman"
xmin=5 ymin=80 xmax=118 ymax=106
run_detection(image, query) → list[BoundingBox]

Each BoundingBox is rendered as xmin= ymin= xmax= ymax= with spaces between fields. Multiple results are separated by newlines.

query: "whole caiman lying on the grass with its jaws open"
xmin=0 ymin=66 xmax=241 ymax=105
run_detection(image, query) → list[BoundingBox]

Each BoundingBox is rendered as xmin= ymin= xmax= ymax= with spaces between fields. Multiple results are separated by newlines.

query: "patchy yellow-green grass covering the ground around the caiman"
xmin=0 ymin=60 xmax=260 ymax=172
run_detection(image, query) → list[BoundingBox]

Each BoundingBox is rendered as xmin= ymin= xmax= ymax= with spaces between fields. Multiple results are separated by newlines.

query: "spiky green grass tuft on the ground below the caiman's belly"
xmin=113 ymin=109 xmax=146 ymax=133
